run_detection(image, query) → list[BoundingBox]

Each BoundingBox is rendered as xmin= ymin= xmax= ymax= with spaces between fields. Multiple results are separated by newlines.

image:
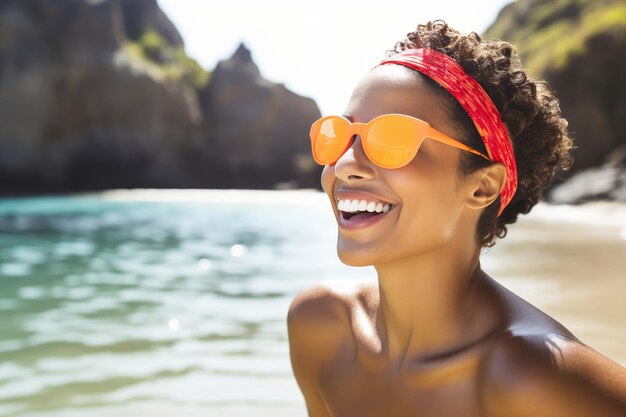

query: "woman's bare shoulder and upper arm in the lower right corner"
xmin=481 ymin=336 xmax=626 ymax=417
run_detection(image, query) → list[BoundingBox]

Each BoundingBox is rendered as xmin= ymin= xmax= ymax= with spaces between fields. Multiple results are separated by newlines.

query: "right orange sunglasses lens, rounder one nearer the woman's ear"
xmin=366 ymin=116 xmax=421 ymax=168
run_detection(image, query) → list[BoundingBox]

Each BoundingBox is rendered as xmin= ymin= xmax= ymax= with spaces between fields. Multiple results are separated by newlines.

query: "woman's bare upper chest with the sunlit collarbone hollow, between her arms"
xmin=320 ymin=290 xmax=492 ymax=417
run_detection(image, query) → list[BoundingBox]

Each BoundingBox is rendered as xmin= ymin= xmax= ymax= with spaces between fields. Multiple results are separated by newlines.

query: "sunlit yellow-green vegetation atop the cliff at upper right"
xmin=483 ymin=0 xmax=626 ymax=76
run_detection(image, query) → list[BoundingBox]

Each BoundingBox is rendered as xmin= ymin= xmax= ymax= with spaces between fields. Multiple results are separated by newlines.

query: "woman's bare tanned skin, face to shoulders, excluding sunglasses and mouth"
xmin=287 ymin=65 xmax=626 ymax=417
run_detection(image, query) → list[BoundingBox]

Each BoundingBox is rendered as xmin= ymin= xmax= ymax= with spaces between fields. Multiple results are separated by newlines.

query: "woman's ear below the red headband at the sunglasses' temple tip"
xmin=465 ymin=162 xmax=506 ymax=210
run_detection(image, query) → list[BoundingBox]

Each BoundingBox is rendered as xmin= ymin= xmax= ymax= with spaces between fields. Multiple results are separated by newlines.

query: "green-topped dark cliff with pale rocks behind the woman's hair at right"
xmin=484 ymin=0 xmax=626 ymax=202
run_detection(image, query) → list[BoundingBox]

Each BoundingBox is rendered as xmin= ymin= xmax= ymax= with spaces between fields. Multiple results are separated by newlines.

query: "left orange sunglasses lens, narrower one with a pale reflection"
xmin=311 ymin=117 xmax=350 ymax=165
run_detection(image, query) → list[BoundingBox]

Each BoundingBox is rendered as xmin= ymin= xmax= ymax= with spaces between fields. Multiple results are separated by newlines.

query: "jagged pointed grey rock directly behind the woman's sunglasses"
xmin=200 ymin=45 xmax=320 ymax=188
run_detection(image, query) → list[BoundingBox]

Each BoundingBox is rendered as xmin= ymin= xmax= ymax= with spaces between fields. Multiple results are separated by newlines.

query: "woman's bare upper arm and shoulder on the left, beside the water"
xmin=287 ymin=284 xmax=345 ymax=417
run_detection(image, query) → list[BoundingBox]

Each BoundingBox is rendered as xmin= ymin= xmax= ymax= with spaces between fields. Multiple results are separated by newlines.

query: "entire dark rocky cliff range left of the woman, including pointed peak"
xmin=0 ymin=0 xmax=319 ymax=194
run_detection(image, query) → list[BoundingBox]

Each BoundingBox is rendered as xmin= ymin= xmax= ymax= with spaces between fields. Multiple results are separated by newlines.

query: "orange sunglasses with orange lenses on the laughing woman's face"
xmin=310 ymin=114 xmax=491 ymax=169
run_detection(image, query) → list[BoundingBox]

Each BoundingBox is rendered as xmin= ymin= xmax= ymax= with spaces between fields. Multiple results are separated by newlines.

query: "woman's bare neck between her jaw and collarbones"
xmin=375 ymin=236 xmax=502 ymax=367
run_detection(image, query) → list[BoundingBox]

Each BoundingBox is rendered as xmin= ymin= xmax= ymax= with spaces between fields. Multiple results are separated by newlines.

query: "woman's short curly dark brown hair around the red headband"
xmin=386 ymin=20 xmax=574 ymax=247
